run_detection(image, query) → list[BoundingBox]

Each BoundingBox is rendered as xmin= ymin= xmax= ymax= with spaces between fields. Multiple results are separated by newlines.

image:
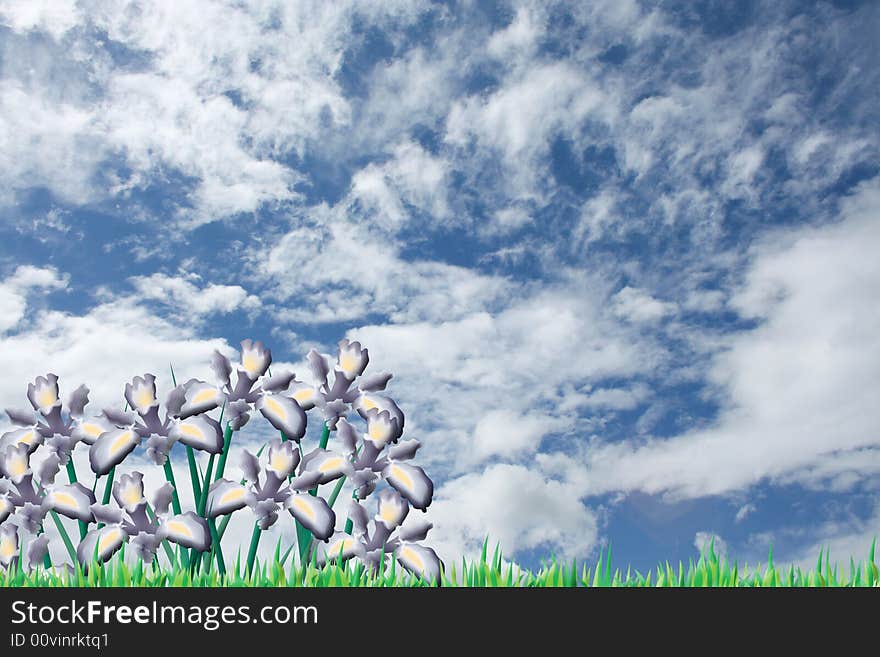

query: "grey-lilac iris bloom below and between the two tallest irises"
xmin=207 ymin=438 xmax=342 ymax=540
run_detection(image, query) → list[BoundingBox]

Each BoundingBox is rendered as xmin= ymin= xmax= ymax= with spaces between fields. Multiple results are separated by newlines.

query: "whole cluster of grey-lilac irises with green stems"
xmin=0 ymin=340 xmax=441 ymax=581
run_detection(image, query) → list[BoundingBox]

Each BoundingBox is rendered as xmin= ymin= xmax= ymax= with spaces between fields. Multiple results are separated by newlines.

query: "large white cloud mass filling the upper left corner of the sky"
xmin=0 ymin=1 xmax=436 ymax=227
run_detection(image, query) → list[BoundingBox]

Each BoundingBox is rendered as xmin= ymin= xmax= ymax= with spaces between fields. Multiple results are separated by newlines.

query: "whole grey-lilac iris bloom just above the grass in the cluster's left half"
xmin=84 ymin=472 xmax=211 ymax=566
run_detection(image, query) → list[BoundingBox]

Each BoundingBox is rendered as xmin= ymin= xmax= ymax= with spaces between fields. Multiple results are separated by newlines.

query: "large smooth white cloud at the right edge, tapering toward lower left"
xmin=590 ymin=183 xmax=880 ymax=496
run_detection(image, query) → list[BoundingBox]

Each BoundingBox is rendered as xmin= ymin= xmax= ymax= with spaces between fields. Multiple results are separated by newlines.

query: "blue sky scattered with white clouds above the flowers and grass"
xmin=0 ymin=0 xmax=880 ymax=569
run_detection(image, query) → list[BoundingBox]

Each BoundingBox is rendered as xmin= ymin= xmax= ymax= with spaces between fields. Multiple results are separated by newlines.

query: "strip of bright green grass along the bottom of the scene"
xmin=0 ymin=544 xmax=880 ymax=587
